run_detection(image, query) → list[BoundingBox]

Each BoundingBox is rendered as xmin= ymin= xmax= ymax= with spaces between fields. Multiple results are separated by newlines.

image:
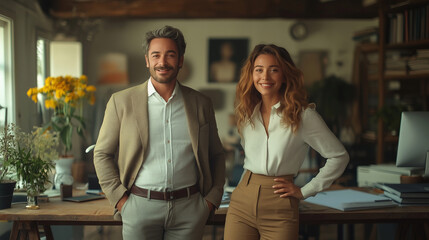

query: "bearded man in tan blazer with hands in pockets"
xmin=94 ymin=26 xmax=225 ymax=240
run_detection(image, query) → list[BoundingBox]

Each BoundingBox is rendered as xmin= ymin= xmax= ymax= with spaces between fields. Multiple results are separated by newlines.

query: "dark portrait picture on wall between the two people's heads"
xmin=208 ymin=38 xmax=249 ymax=83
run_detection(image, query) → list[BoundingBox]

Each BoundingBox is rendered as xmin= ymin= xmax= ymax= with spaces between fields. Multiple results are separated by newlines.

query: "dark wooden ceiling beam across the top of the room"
xmin=45 ymin=0 xmax=377 ymax=19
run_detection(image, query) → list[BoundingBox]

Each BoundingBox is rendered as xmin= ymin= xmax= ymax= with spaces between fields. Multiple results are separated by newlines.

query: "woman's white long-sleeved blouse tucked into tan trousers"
xmin=241 ymin=103 xmax=349 ymax=198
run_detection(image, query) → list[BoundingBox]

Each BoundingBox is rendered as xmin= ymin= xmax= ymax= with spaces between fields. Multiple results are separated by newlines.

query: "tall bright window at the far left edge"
xmin=0 ymin=15 xmax=15 ymax=126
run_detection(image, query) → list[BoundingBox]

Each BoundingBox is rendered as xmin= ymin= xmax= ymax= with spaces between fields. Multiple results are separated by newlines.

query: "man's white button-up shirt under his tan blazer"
xmin=135 ymin=79 xmax=197 ymax=191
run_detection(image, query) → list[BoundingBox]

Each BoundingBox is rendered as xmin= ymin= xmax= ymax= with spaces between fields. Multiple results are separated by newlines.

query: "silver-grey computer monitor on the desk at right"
xmin=396 ymin=112 xmax=429 ymax=175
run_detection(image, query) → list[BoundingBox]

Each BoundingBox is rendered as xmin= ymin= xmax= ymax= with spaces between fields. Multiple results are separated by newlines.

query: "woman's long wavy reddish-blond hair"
xmin=234 ymin=44 xmax=309 ymax=133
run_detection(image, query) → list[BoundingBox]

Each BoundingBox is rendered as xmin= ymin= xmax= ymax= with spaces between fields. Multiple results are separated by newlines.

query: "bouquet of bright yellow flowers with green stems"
xmin=27 ymin=75 xmax=96 ymax=155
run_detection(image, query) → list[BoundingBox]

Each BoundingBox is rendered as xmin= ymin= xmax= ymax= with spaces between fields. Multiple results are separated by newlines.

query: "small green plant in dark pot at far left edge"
xmin=0 ymin=125 xmax=16 ymax=209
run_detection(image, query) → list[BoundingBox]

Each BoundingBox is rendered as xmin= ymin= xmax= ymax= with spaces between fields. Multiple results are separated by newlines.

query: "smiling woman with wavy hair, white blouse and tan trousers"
xmin=225 ymin=44 xmax=349 ymax=240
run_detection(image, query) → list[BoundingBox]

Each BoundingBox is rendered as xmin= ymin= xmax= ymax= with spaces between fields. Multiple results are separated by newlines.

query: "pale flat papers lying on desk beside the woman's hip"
xmin=304 ymin=189 xmax=397 ymax=211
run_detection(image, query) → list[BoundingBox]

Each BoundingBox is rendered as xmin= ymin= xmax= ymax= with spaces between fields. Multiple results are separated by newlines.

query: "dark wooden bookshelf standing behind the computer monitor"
xmin=356 ymin=0 xmax=429 ymax=164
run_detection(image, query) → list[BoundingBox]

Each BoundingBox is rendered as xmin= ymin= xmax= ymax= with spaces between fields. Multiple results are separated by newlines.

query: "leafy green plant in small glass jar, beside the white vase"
xmin=2 ymin=125 xmax=59 ymax=209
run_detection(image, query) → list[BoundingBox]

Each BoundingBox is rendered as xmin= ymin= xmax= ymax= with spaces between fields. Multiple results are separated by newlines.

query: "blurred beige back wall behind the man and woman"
xmin=84 ymin=19 xmax=377 ymax=142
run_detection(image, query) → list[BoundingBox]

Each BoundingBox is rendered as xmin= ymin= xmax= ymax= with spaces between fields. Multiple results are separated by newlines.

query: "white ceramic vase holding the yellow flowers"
xmin=54 ymin=156 xmax=74 ymax=190
